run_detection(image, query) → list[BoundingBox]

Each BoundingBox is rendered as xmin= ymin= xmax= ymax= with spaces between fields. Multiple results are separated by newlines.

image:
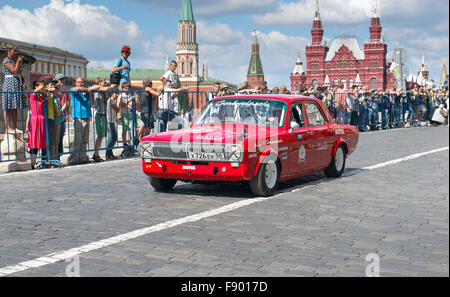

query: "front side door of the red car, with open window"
xmin=281 ymin=102 xmax=313 ymax=176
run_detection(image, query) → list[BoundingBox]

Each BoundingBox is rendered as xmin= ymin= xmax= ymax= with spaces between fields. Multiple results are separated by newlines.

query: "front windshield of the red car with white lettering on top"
xmin=194 ymin=98 xmax=286 ymax=127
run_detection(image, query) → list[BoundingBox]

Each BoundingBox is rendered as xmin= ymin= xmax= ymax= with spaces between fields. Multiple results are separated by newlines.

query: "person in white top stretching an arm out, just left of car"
xmin=158 ymin=79 xmax=188 ymax=133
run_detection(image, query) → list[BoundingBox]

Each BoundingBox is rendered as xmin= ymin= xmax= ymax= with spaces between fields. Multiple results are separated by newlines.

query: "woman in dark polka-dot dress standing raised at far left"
xmin=2 ymin=44 xmax=25 ymax=134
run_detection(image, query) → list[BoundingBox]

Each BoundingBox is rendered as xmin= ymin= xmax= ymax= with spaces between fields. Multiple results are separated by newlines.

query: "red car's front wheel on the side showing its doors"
xmin=250 ymin=160 xmax=280 ymax=197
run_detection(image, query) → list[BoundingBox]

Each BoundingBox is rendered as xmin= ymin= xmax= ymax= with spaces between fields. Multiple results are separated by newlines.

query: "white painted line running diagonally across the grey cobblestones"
xmin=0 ymin=147 xmax=449 ymax=277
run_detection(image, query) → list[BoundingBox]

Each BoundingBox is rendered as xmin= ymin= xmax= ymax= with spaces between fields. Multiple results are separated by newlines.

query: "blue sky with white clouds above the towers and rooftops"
xmin=0 ymin=0 xmax=449 ymax=87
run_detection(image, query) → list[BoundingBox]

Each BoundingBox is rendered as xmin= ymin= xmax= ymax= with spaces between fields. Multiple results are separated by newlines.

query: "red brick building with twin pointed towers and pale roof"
xmin=290 ymin=1 xmax=395 ymax=92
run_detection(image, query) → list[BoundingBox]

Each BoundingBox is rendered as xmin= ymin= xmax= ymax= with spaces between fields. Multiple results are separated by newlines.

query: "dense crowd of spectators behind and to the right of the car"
xmin=209 ymin=77 xmax=449 ymax=132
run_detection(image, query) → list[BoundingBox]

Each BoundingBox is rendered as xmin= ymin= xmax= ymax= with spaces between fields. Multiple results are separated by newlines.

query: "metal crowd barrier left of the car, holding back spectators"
xmin=0 ymin=90 xmax=208 ymax=167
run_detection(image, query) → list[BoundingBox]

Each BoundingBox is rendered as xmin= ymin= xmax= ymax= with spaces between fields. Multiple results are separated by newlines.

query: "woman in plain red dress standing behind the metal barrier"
xmin=28 ymin=80 xmax=47 ymax=169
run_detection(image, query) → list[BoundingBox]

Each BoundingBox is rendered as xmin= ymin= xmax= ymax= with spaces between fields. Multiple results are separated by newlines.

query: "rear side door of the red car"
xmin=304 ymin=101 xmax=334 ymax=170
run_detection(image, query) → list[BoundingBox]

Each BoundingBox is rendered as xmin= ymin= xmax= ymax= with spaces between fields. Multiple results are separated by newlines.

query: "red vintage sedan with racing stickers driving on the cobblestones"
xmin=139 ymin=95 xmax=359 ymax=196
